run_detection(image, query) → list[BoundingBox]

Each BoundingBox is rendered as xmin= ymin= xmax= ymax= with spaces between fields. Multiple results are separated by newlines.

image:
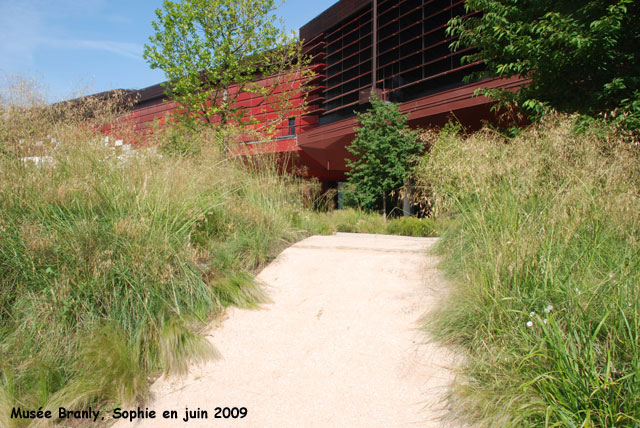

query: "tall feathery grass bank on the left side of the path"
xmin=0 ymin=78 xmax=318 ymax=426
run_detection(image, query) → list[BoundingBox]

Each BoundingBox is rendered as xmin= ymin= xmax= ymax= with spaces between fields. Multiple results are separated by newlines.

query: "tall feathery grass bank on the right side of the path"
xmin=420 ymin=116 xmax=640 ymax=427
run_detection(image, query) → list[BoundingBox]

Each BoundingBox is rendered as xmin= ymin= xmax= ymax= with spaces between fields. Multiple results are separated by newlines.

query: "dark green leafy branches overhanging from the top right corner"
xmin=449 ymin=0 xmax=640 ymax=129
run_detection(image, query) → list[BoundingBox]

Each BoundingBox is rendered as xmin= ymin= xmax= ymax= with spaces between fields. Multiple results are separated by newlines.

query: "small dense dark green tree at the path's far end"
xmin=346 ymin=96 xmax=424 ymax=218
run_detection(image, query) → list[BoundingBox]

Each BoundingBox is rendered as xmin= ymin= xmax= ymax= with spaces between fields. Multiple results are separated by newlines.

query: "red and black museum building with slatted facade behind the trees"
xmin=102 ymin=0 xmax=524 ymax=180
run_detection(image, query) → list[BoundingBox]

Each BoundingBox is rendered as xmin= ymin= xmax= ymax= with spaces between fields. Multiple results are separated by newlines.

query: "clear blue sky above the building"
xmin=0 ymin=0 xmax=337 ymax=101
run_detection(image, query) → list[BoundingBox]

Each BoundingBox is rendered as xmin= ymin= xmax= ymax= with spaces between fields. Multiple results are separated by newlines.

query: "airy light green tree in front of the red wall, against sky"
xmin=144 ymin=0 xmax=310 ymax=144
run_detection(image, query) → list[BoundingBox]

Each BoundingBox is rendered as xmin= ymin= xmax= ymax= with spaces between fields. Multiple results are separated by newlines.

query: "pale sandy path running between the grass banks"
xmin=115 ymin=233 xmax=462 ymax=428
